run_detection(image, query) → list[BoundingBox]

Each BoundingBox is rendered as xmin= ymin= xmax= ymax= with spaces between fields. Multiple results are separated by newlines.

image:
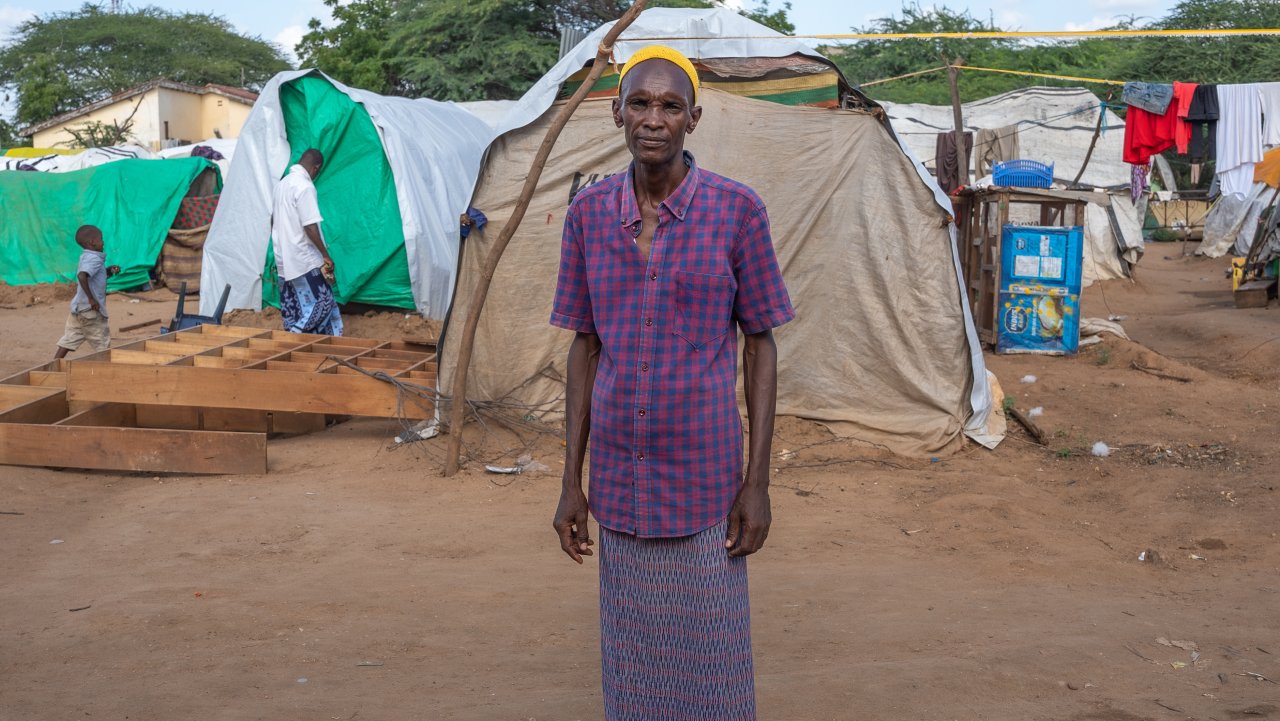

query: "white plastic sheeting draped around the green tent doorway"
xmin=201 ymin=70 xmax=494 ymax=319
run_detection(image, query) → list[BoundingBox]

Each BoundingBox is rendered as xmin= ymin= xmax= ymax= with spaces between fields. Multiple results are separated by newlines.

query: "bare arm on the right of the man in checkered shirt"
xmin=724 ymin=330 xmax=778 ymax=556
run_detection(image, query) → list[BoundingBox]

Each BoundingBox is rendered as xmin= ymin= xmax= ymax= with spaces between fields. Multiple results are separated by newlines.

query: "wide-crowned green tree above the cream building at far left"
xmin=0 ymin=4 xmax=289 ymax=126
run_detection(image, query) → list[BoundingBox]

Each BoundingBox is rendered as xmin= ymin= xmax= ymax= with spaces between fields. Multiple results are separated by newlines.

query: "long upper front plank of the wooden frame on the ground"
xmin=68 ymin=362 xmax=431 ymax=419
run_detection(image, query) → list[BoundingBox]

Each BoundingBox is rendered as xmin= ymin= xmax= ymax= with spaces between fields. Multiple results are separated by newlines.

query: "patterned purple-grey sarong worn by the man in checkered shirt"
xmin=600 ymin=521 xmax=755 ymax=721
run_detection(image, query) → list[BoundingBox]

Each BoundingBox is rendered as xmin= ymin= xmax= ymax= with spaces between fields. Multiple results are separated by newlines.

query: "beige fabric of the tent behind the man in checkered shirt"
xmin=440 ymin=90 xmax=973 ymax=455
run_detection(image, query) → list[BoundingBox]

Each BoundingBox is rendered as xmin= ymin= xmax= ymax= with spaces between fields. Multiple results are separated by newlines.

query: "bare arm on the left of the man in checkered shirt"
xmin=552 ymin=333 xmax=600 ymax=563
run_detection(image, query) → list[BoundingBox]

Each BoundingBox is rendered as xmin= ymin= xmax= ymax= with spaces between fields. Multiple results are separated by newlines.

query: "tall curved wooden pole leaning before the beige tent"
xmin=444 ymin=0 xmax=648 ymax=476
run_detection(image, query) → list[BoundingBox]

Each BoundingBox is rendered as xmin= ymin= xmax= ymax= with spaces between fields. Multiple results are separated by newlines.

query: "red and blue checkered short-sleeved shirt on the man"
xmin=552 ymin=152 xmax=795 ymax=537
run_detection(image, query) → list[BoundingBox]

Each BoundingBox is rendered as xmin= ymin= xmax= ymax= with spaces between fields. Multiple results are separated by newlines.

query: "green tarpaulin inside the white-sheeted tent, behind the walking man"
xmin=262 ymin=74 xmax=413 ymax=309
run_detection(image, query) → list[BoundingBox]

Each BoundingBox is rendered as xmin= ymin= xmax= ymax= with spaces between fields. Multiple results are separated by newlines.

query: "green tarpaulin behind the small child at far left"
xmin=0 ymin=158 xmax=221 ymax=291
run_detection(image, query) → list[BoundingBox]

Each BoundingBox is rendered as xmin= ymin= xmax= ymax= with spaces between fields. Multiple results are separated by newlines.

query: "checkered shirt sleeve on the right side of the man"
xmin=733 ymin=206 xmax=796 ymax=336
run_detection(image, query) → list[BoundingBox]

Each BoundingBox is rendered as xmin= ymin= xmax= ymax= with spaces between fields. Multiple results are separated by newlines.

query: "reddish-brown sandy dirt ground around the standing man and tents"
xmin=0 ymin=245 xmax=1280 ymax=721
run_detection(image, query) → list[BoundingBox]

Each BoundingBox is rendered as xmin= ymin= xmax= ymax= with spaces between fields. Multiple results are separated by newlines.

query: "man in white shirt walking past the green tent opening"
xmin=271 ymin=147 xmax=342 ymax=336
